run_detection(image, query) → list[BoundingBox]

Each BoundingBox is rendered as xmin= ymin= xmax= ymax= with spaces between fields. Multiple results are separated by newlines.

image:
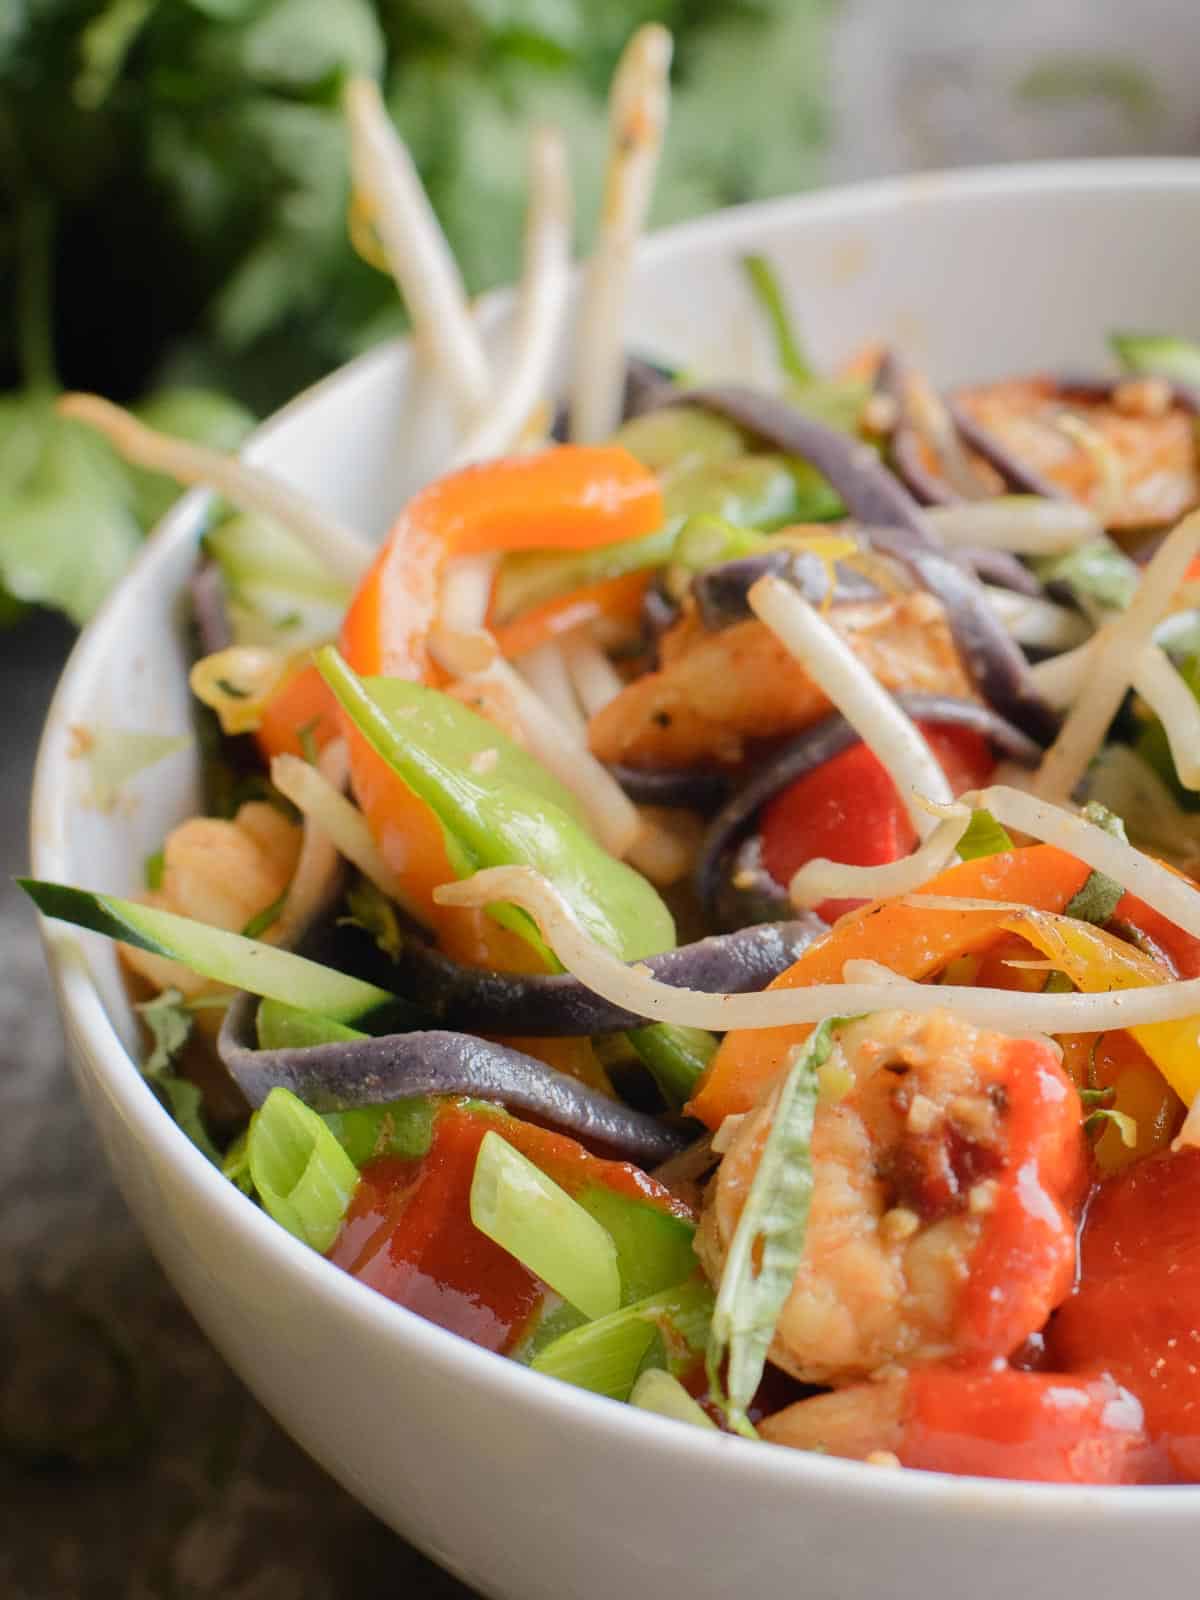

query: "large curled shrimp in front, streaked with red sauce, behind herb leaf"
xmin=698 ymin=1011 xmax=1086 ymax=1384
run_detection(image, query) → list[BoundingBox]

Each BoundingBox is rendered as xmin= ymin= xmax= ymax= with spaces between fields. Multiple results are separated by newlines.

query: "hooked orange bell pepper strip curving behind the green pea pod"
xmin=341 ymin=445 xmax=662 ymax=971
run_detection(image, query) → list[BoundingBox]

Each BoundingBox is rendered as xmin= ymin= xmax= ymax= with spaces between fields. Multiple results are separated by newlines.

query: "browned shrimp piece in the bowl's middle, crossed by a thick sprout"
xmin=589 ymin=594 xmax=974 ymax=766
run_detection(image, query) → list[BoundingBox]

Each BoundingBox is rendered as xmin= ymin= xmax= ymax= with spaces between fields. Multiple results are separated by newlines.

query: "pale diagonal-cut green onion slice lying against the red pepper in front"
xmin=470 ymin=1133 xmax=621 ymax=1317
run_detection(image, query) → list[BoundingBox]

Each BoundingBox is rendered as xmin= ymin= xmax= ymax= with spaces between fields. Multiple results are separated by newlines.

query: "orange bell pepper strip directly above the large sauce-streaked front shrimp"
xmin=685 ymin=845 xmax=1090 ymax=1128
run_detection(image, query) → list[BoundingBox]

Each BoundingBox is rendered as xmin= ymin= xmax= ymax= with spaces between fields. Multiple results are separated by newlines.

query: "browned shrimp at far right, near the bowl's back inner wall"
xmin=957 ymin=378 xmax=1200 ymax=528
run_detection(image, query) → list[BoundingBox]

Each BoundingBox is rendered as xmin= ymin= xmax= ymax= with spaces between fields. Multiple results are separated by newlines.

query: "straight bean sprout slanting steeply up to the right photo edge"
xmin=1034 ymin=512 xmax=1200 ymax=800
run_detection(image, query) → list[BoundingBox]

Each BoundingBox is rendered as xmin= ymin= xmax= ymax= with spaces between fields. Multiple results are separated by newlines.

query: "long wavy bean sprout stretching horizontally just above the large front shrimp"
xmin=434 ymin=864 xmax=1200 ymax=1035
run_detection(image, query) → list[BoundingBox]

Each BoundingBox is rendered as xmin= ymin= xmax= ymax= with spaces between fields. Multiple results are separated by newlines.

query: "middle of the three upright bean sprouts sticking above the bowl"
xmin=454 ymin=128 xmax=571 ymax=466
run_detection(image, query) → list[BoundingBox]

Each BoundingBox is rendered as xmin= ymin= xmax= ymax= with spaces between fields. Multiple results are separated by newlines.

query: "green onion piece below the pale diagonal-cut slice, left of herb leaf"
xmin=530 ymin=1278 xmax=712 ymax=1400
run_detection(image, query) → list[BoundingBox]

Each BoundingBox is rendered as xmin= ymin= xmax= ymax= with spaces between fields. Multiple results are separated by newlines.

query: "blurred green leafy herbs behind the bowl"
xmin=0 ymin=0 xmax=834 ymax=621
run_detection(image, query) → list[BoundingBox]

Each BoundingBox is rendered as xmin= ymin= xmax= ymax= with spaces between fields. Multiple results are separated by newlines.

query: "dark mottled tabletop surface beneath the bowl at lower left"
xmin=0 ymin=618 xmax=470 ymax=1600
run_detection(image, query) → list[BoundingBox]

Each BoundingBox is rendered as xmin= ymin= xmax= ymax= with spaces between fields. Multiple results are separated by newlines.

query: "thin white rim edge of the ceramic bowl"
xmin=30 ymin=157 xmax=1200 ymax=1533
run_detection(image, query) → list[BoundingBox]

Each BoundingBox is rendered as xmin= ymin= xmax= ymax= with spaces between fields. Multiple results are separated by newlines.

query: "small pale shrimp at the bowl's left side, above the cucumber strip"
xmin=120 ymin=800 xmax=301 ymax=994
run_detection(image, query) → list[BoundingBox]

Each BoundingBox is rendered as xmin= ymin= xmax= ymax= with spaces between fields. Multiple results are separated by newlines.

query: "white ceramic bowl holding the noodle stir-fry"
xmin=32 ymin=162 xmax=1200 ymax=1600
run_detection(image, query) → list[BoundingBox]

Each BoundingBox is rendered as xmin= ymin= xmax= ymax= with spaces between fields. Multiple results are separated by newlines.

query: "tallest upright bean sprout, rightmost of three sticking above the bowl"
xmin=571 ymin=22 xmax=672 ymax=443
